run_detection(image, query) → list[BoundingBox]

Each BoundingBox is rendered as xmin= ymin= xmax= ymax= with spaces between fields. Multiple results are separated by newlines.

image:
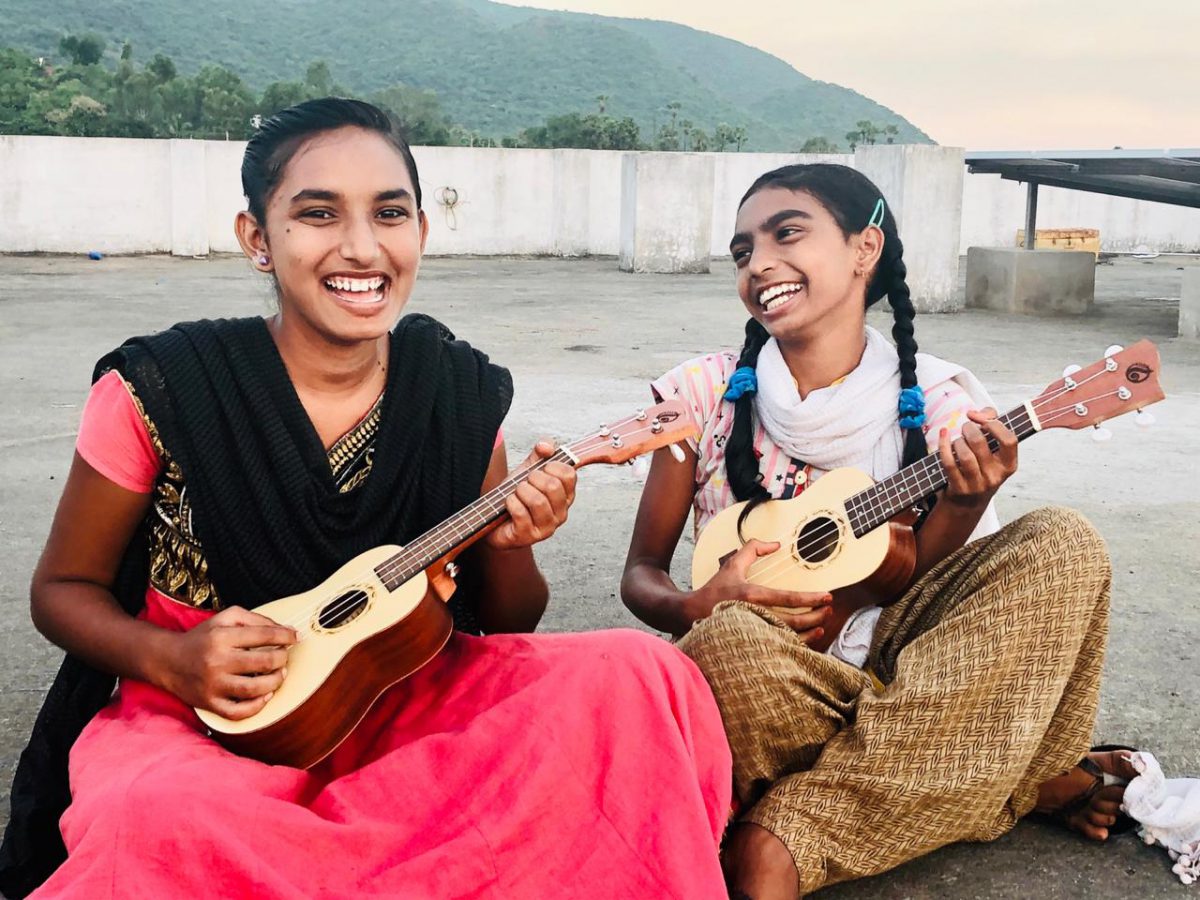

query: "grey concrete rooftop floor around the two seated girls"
xmin=0 ymin=257 xmax=1200 ymax=898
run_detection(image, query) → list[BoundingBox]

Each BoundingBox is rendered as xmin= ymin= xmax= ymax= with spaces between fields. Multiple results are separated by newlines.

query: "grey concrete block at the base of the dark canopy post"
xmin=966 ymin=247 xmax=1096 ymax=314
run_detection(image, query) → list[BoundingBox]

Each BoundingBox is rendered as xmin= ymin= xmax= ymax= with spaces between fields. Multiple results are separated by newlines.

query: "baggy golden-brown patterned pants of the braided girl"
xmin=679 ymin=508 xmax=1111 ymax=893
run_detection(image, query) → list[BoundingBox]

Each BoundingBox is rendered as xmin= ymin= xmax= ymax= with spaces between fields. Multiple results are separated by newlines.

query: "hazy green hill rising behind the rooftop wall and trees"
xmin=0 ymin=0 xmax=929 ymax=150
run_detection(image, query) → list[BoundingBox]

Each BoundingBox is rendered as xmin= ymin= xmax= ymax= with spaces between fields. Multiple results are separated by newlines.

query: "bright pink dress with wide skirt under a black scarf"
xmin=36 ymin=372 xmax=731 ymax=900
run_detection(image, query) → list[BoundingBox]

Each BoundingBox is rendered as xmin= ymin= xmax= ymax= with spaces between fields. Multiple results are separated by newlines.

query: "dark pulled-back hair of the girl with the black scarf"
xmin=241 ymin=97 xmax=421 ymax=228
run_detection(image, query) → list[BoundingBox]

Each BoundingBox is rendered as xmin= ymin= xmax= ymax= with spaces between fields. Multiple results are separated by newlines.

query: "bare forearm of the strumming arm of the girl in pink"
xmin=31 ymin=581 xmax=175 ymax=686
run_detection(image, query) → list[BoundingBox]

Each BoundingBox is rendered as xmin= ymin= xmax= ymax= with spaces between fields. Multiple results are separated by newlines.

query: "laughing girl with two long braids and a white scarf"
xmin=622 ymin=164 xmax=1133 ymax=900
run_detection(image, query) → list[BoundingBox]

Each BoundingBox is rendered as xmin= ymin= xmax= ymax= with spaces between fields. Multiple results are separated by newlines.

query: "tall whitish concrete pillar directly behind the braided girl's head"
xmin=854 ymin=144 xmax=965 ymax=312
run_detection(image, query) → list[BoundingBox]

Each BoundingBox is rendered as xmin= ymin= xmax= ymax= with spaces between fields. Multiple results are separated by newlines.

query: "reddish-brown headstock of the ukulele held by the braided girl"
xmin=1028 ymin=340 xmax=1165 ymax=431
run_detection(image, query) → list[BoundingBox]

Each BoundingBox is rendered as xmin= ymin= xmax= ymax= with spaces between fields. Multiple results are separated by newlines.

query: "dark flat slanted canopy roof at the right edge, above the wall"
xmin=966 ymin=149 xmax=1200 ymax=208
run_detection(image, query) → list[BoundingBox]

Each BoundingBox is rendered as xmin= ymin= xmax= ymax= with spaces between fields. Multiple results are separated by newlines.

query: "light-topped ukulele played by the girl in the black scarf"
xmin=196 ymin=401 xmax=696 ymax=768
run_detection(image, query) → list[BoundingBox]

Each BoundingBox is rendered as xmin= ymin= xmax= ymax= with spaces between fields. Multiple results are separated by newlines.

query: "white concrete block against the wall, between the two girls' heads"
xmin=618 ymin=154 xmax=715 ymax=274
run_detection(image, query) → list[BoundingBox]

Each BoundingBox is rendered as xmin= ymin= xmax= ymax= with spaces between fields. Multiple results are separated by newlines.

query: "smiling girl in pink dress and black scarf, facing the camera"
xmin=0 ymin=97 xmax=730 ymax=900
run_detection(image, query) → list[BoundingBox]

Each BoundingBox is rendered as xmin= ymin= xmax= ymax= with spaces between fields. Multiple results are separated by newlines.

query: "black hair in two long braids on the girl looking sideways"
xmin=725 ymin=163 xmax=928 ymax=518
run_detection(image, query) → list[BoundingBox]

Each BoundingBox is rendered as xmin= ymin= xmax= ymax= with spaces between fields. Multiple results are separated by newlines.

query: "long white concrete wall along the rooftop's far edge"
xmin=0 ymin=136 xmax=1200 ymax=256
